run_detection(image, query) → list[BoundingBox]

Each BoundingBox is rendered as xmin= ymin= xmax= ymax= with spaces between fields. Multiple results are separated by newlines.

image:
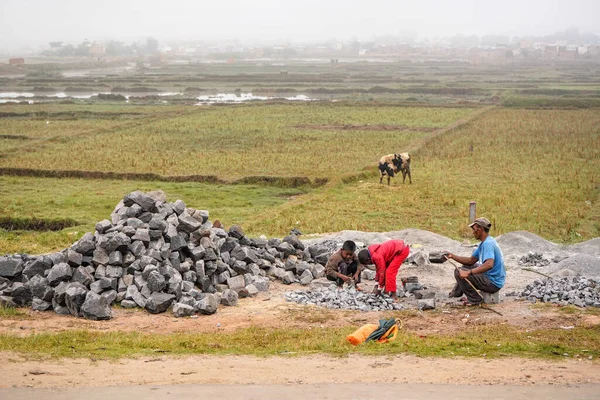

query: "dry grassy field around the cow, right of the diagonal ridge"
xmin=241 ymin=110 xmax=600 ymax=242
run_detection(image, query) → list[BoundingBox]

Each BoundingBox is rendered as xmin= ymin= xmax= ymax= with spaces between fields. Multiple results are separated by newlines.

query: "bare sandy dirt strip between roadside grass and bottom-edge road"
xmin=0 ymin=353 xmax=600 ymax=388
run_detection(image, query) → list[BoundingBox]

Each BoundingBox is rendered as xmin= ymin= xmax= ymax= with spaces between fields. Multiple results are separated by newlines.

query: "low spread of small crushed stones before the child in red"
xmin=285 ymin=285 xmax=404 ymax=311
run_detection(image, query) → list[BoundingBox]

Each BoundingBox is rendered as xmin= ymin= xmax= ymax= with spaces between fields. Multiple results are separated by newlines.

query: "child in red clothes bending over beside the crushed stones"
xmin=358 ymin=240 xmax=410 ymax=300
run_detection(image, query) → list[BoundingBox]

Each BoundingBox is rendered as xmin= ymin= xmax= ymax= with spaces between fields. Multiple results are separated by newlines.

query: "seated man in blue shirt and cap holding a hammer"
xmin=446 ymin=218 xmax=506 ymax=305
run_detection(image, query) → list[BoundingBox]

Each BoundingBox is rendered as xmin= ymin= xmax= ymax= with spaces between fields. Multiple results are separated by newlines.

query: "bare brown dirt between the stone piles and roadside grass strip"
xmin=0 ymin=283 xmax=600 ymax=336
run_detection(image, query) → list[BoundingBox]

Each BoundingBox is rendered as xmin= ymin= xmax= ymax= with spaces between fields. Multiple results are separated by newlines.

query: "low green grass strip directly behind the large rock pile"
xmin=0 ymin=176 xmax=310 ymax=254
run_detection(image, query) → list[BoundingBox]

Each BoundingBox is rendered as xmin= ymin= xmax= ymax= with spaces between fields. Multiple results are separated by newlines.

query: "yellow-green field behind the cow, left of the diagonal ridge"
xmin=0 ymin=103 xmax=472 ymax=180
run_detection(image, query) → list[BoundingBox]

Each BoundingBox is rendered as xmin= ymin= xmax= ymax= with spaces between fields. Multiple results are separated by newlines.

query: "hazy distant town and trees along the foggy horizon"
xmin=4 ymin=29 xmax=600 ymax=65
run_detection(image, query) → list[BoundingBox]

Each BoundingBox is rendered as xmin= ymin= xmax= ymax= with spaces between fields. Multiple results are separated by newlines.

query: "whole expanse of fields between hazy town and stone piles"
xmin=0 ymin=61 xmax=600 ymax=253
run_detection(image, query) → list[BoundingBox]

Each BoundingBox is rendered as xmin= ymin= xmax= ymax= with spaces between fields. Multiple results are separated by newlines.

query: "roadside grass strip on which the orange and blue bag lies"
xmin=0 ymin=326 xmax=600 ymax=359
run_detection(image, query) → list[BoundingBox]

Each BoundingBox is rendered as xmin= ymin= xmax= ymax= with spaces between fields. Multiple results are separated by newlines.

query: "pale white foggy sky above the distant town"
xmin=0 ymin=0 xmax=600 ymax=49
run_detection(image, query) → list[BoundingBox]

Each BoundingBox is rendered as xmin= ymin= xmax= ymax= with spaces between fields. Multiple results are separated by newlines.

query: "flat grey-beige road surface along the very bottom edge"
xmin=5 ymin=383 xmax=600 ymax=400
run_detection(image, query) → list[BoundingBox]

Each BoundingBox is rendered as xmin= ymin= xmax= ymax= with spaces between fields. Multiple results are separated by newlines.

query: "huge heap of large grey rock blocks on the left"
xmin=0 ymin=191 xmax=340 ymax=320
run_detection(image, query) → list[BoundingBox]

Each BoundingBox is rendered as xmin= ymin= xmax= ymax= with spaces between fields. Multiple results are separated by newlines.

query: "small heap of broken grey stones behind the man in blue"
xmin=521 ymin=277 xmax=600 ymax=307
